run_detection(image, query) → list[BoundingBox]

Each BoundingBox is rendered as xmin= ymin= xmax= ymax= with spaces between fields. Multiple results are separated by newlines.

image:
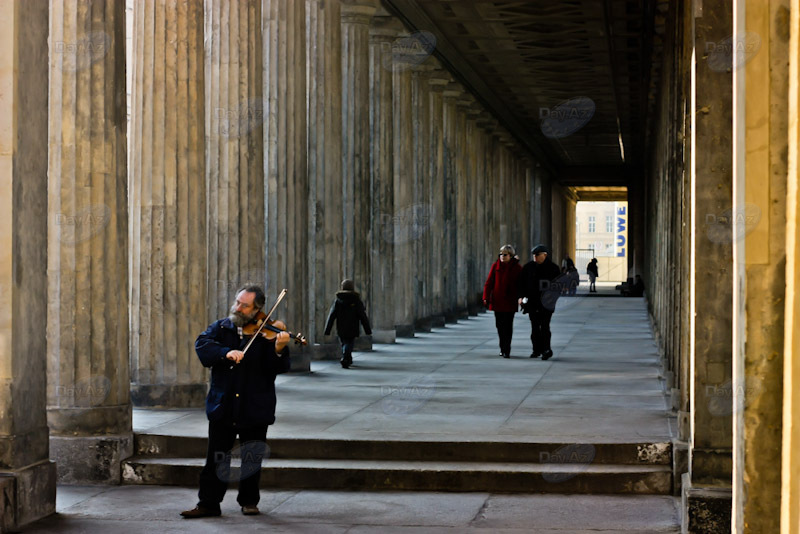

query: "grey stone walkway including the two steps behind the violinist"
xmin=26 ymin=284 xmax=680 ymax=534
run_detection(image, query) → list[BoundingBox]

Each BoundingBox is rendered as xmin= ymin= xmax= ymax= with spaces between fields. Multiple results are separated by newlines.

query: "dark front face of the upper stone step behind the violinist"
xmin=135 ymin=433 xmax=672 ymax=466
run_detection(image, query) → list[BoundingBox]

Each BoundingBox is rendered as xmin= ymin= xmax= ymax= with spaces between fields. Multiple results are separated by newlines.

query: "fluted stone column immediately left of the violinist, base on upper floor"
xmin=129 ymin=0 xmax=208 ymax=408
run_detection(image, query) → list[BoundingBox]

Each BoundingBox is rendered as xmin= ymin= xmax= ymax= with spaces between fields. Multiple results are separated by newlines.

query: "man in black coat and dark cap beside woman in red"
xmin=519 ymin=245 xmax=561 ymax=360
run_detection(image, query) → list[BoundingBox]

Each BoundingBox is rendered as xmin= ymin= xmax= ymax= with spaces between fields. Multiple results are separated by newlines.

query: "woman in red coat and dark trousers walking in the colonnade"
xmin=483 ymin=245 xmax=522 ymax=358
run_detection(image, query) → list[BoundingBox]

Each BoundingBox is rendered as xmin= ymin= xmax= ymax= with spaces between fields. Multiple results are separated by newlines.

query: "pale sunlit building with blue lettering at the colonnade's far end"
xmin=575 ymin=202 xmax=628 ymax=282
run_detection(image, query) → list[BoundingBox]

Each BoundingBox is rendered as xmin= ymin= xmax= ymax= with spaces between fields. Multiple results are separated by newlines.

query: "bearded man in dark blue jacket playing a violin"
xmin=181 ymin=285 xmax=291 ymax=518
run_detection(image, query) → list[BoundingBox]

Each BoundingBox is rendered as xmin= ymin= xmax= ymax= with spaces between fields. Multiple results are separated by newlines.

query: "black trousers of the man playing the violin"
xmin=198 ymin=422 xmax=267 ymax=510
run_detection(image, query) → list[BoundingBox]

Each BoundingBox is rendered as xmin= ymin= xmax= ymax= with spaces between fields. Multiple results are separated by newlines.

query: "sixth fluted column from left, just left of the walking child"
xmin=305 ymin=0 xmax=342 ymax=359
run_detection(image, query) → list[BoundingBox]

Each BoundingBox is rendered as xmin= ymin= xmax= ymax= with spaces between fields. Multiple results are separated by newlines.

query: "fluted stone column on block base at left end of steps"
xmin=47 ymin=0 xmax=133 ymax=484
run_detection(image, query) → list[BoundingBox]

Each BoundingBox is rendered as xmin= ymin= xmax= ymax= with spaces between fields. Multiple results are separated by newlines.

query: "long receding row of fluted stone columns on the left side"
xmin=0 ymin=0 xmax=544 ymax=510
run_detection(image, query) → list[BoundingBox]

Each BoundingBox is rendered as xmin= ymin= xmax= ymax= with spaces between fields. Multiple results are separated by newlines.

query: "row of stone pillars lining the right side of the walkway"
xmin=646 ymin=0 xmax=799 ymax=532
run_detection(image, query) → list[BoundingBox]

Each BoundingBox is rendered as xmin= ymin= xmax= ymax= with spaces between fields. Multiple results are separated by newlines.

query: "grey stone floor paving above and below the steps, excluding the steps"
xmin=24 ymin=284 xmax=680 ymax=534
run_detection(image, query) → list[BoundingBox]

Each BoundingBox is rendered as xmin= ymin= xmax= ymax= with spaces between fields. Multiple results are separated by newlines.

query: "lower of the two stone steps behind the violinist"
xmin=123 ymin=456 xmax=672 ymax=495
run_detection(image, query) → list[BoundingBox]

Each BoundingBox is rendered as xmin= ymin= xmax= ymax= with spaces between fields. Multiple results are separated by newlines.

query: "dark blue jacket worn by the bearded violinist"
xmin=194 ymin=317 xmax=291 ymax=428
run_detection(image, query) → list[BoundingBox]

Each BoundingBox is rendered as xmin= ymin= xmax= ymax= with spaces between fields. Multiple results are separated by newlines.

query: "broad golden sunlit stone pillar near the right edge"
xmin=731 ymin=0 xmax=797 ymax=532
